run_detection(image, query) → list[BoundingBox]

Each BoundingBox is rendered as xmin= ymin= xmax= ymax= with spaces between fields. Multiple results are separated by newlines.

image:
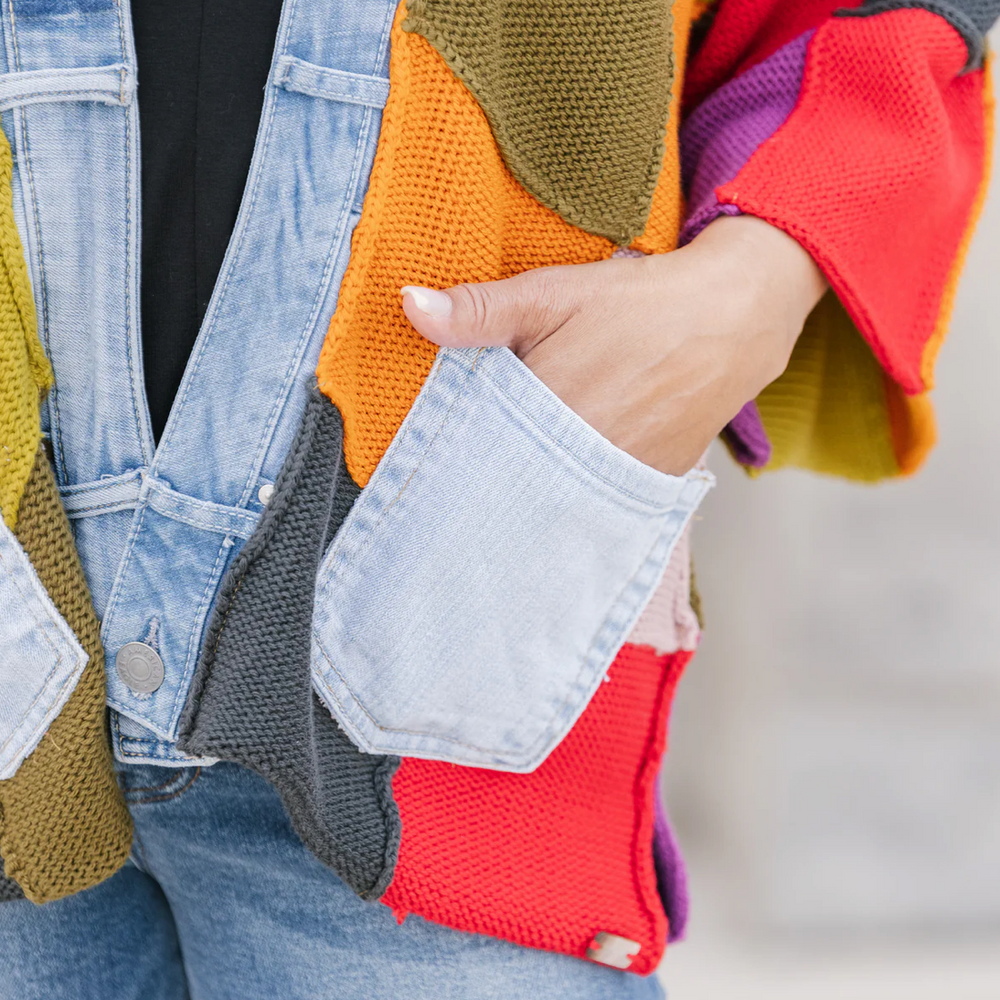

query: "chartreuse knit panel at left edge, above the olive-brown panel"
xmin=0 ymin=132 xmax=52 ymax=529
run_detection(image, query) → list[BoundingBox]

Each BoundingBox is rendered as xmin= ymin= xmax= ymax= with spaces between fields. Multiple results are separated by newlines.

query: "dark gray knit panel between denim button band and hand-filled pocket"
xmin=178 ymin=390 xmax=400 ymax=899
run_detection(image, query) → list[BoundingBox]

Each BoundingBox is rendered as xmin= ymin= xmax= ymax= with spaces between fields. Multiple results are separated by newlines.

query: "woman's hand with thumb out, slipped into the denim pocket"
xmin=403 ymin=216 xmax=826 ymax=475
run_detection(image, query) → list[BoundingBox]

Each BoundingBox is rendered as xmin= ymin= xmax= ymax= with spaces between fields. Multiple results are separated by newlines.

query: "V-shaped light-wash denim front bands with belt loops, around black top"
xmin=0 ymin=0 xmax=396 ymax=764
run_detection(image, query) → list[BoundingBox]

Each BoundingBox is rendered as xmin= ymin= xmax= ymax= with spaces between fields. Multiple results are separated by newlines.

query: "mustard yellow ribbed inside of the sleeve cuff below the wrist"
xmin=757 ymin=293 xmax=900 ymax=482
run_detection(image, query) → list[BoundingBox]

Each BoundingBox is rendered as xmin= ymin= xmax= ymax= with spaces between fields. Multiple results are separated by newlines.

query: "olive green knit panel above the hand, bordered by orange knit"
xmin=403 ymin=0 xmax=674 ymax=245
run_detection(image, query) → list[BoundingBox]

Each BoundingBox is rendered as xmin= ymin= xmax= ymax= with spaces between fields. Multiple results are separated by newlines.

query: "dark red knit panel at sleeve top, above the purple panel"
xmin=684 ymin=0 xmax=861 ymax=110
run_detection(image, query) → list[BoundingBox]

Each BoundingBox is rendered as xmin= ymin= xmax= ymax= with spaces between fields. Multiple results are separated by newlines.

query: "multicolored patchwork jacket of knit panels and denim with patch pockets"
xmin=0 ymin=0 xmax=996 ymax=973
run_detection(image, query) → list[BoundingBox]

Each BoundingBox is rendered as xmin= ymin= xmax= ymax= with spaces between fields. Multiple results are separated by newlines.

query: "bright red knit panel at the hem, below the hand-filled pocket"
xmin=382 ymin=645 xmax=692 ymax=974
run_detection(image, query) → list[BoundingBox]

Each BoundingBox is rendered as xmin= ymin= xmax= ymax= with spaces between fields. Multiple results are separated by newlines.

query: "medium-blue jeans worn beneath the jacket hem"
xmin=0 ymin=764 xmax=663 ymax=1000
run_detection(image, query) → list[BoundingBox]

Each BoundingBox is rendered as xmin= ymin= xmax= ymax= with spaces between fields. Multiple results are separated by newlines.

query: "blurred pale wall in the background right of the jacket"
xmin=663 ymin=27 xmax=1000 ymax=1000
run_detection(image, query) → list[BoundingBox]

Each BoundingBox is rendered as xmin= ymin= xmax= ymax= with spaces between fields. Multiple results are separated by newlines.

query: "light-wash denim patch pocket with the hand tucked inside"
xmin=312 ymin=348 xmax=713 ymax=772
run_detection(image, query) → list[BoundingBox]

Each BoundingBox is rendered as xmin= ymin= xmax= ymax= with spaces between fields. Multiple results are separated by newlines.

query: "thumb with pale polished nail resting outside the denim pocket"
xmin=401 ymin=268 xmax=574 ymax=355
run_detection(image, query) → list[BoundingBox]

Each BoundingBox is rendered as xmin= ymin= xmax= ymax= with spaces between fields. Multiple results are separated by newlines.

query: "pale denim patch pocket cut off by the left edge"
xmin=0 ymin=520 xmax=87 ymax=780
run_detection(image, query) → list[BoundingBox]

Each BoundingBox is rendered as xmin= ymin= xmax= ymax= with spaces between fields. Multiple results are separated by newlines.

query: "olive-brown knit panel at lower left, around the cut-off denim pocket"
xmin=0 ymin=447 xmax=132 ymax=903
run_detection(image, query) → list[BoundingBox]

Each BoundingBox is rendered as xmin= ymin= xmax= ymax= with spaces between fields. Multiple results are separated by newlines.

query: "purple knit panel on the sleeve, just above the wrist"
xmin=678 ymin=31 xmax=813 ymax=246
